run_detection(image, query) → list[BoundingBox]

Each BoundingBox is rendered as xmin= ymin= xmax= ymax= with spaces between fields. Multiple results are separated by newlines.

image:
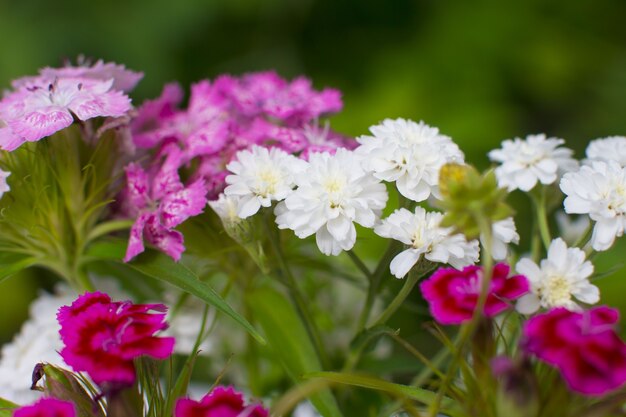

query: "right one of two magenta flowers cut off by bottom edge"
xmin=174 ymin=387 xmax=269 ymax=417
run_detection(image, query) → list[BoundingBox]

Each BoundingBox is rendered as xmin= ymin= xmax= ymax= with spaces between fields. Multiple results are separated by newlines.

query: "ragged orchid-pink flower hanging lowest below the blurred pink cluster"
xmin=123 ymin=144 xmax=207 ymax=262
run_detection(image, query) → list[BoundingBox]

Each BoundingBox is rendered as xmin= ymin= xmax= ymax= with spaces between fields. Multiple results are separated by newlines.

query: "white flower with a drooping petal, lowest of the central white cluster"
xmin=374 ymin=207 xmax=478 ymax=278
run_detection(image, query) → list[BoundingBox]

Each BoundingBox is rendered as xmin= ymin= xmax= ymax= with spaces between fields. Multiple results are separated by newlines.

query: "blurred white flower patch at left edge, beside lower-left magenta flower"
xmin=0 ymin=287 xmax=76 ymax=404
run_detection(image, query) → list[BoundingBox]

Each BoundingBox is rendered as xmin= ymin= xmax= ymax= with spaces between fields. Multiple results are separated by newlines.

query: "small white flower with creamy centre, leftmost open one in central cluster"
xmin=224 ymin=145 xmax=304 ymax=219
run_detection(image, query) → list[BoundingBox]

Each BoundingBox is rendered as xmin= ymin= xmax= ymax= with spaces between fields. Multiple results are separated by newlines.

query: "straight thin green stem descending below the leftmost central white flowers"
xmin=263 ymin=212 xmax=330 ymax=368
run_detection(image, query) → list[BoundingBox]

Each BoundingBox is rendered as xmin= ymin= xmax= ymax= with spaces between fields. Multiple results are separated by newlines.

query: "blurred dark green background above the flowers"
xmin=0 ymin=0 xmax=626 ymax=340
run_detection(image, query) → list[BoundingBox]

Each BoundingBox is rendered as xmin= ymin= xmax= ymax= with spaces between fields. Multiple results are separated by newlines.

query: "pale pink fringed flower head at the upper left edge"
xmin=0 ymin=77 xmax=130 ymax=151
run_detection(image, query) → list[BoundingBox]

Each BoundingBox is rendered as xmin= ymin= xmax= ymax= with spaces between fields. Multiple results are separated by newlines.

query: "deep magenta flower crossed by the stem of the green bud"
xmin=421 ymin=263 xmax=529 ymax=324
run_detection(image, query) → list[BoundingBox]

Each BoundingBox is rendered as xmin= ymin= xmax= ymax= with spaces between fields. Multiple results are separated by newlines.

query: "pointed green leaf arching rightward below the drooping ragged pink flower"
xmin=127 ymin=250 xmax=266 ymax=344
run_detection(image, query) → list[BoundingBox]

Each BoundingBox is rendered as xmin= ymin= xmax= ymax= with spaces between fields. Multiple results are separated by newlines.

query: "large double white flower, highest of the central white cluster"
xmin=355 ymin=119 xmax=463 ymax=201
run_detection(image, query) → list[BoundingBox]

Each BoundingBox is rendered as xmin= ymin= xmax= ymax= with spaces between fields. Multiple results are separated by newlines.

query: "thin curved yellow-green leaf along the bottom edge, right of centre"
xmin=305 ymin=372 xmax=460 ymax=417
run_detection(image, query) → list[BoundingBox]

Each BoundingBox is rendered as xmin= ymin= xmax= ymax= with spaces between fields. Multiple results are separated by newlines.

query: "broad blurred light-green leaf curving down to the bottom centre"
xmin=246 ymin=287 xmax=342 ymax=417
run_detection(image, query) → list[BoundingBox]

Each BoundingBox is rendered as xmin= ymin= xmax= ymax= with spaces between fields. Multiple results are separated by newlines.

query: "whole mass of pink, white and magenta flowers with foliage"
xmin=0 ymin=61 xmax=626 ymax=417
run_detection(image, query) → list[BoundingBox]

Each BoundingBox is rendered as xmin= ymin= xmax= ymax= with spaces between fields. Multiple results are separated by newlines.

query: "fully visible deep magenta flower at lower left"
xmin=57 ymin=292 xmax=174 ymax=387
